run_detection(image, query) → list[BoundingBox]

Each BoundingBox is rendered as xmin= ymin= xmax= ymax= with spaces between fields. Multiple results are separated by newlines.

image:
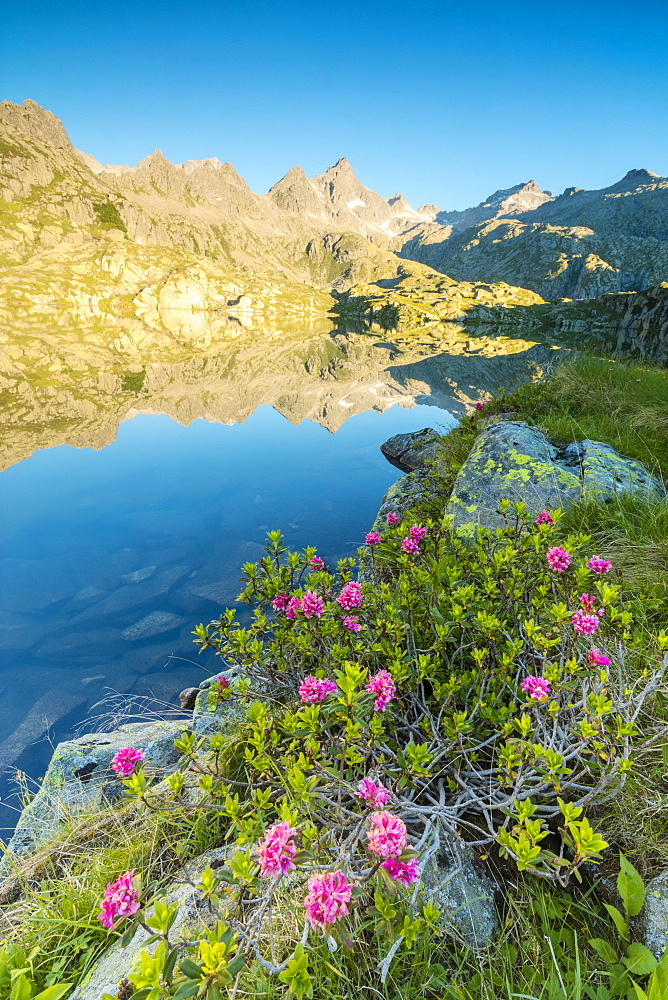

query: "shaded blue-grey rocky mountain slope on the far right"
xmin=396 ymin=170 xmax=668 ymax=299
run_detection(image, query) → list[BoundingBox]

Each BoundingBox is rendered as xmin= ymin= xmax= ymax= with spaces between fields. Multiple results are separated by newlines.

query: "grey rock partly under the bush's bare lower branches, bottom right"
xmin=422 ymin=838 xmax=499 ymax=950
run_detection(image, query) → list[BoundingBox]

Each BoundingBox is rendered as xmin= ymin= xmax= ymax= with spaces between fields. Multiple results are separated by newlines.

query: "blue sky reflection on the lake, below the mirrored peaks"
xmin=0 ymin=406 xmax=453 ymax=826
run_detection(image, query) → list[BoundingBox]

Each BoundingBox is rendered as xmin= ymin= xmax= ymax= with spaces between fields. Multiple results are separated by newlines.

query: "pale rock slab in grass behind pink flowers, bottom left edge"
xmin=70 ymin=847 xmax=228 ymax=1000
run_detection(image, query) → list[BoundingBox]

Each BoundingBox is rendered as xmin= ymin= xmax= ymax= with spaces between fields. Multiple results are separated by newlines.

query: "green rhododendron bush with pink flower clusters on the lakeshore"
xmin=107 ymin=504 xmax=668 ymax=996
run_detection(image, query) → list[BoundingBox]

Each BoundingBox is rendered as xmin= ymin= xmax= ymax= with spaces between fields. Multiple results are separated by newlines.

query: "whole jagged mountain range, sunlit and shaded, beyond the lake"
xmin=0 ymin=100 xmax=668 ymax=360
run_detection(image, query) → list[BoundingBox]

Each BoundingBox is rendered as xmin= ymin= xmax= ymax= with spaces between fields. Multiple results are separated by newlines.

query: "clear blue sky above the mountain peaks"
xmin=0 ymin=0 xmax=668 ymax=209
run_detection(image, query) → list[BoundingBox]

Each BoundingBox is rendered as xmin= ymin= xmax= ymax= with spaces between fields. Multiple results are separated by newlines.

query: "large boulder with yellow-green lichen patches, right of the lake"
xmin=446 ymin=420 xmax=580 ymax=534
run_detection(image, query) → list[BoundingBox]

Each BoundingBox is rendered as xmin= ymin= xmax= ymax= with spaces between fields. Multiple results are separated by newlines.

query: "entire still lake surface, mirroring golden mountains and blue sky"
xmin=0 ymin=322 xmax=564 ymax=828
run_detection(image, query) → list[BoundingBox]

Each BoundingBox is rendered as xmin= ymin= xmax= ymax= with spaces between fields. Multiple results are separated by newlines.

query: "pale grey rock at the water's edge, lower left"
xmin=0 ymin=720 xmax=192 ymax=875
